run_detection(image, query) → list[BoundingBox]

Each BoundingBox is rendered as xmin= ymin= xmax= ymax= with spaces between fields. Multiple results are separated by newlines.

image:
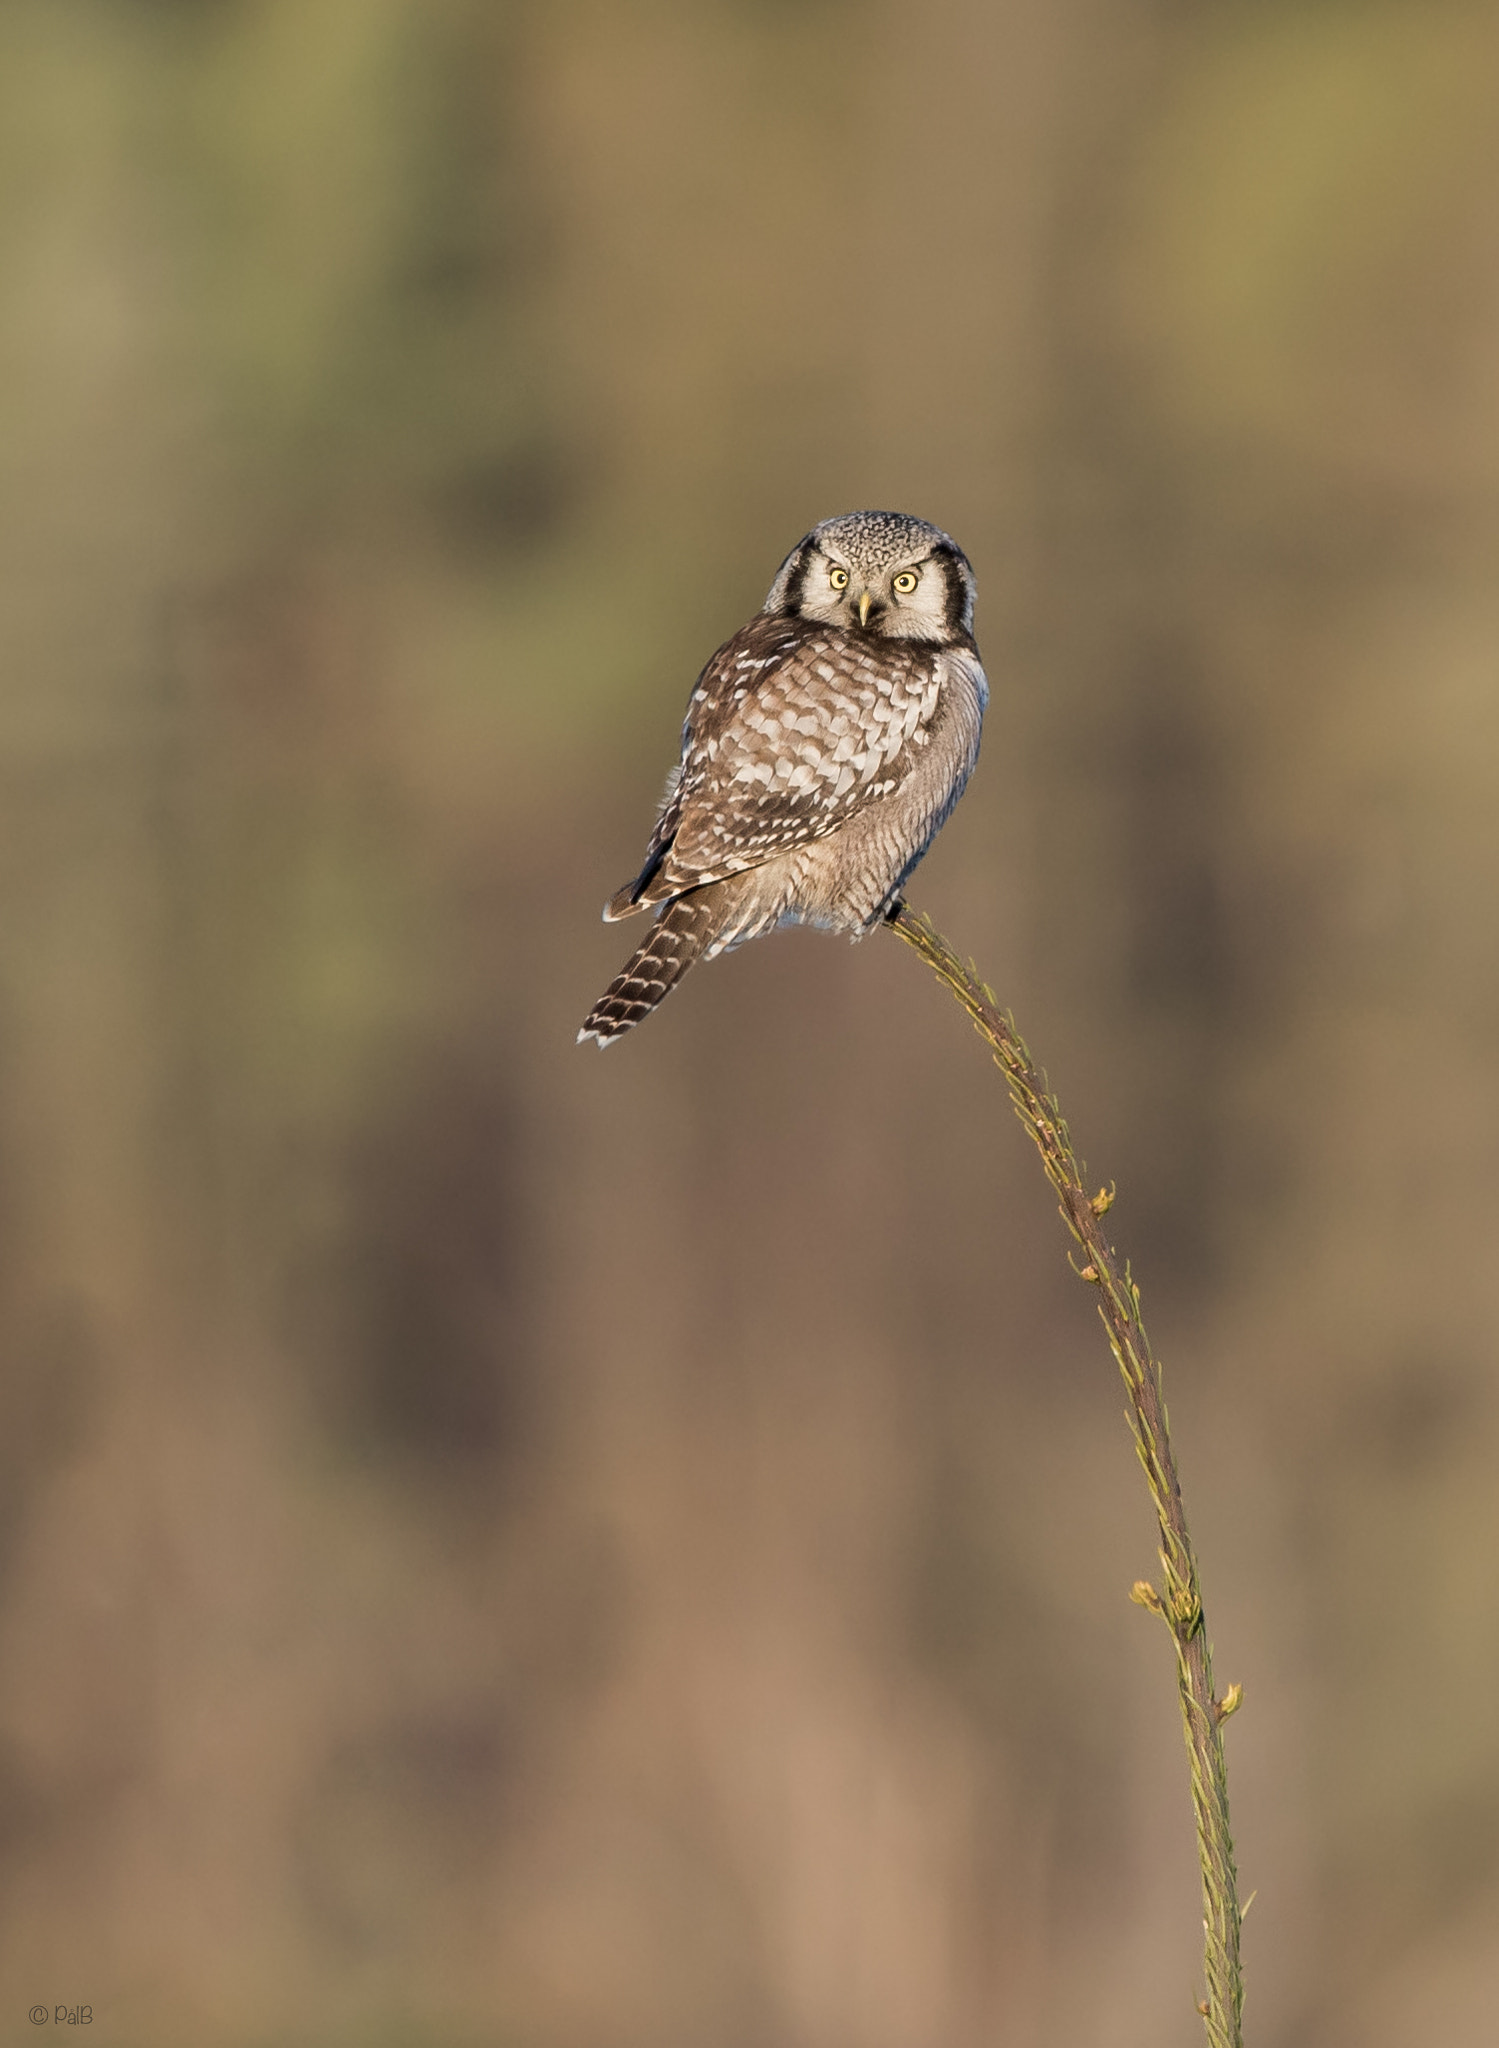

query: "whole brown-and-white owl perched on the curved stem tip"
xmin=577 ymin=512 xmax=989 ymax=1047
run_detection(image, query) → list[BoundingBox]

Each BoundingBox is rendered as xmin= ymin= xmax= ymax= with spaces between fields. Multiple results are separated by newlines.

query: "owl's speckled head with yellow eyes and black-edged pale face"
xmin=764 ymin=512 xmax=973 ymax=645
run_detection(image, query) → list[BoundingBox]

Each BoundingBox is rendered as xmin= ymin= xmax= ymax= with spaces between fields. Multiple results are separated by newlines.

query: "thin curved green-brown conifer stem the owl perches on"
xmin=889 ymin=905 xmax=1243 ymax=2048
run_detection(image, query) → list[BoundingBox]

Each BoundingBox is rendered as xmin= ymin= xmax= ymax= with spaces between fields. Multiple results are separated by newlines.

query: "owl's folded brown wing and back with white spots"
xmin=610 ymin=616 xmax=942 ymax=915
